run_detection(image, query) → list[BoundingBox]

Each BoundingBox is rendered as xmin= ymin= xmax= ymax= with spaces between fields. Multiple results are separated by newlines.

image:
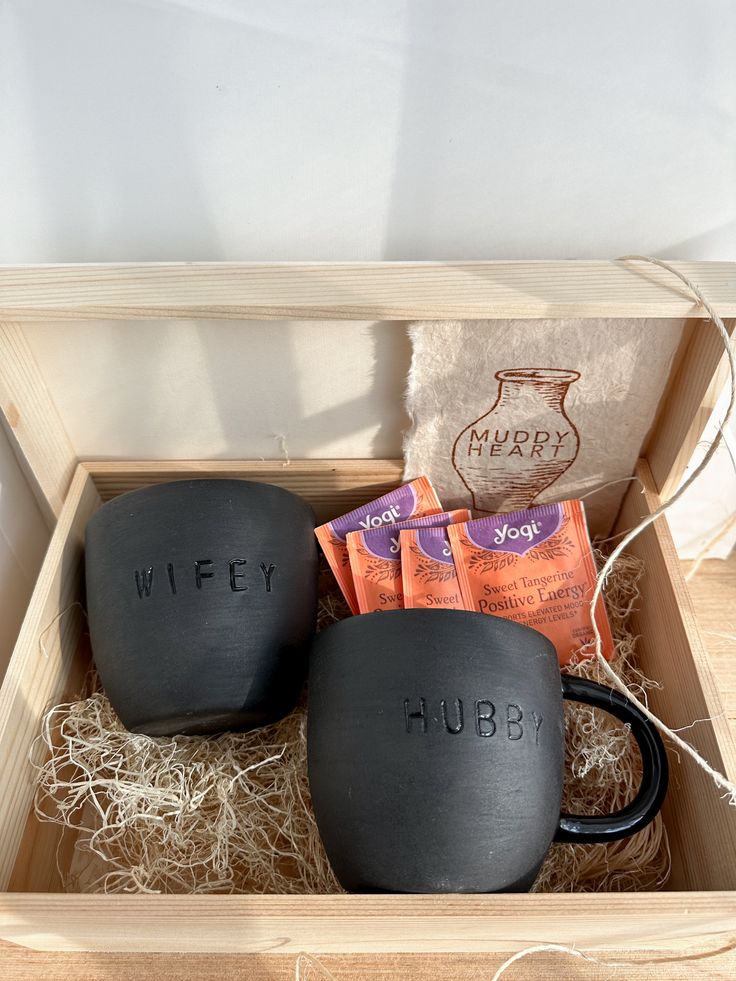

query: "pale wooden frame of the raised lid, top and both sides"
xmin=0 ymin=260 xmax=736 ymax=525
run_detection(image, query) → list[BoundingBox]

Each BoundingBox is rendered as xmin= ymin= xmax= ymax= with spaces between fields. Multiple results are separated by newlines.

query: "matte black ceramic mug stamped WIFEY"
xmin=86 ymin=479 xmax=317 ymax=735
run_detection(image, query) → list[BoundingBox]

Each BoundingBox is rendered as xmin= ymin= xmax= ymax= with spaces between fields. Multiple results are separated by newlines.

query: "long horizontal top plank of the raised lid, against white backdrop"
xmin=0 ymin=261 xmax=736 ymax=321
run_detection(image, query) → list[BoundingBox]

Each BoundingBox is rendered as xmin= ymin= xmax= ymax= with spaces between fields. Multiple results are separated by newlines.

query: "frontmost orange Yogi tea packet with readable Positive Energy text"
xmin=448 ymin=501 xmax=613 ymax=664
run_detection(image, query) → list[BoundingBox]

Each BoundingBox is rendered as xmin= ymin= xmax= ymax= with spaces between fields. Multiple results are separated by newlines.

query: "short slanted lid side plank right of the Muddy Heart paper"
xmin=644 ymin=319 xmax=736 ymax=498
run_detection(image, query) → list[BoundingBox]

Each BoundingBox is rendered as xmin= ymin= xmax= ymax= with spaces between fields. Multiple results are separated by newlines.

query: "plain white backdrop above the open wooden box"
xmin=5 ymin=0 xmax=734 ymax=261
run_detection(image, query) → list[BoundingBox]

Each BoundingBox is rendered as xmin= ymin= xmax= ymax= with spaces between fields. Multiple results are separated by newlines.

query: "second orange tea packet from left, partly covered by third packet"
xmin=347 ymin=508 xmax=470 ymax=613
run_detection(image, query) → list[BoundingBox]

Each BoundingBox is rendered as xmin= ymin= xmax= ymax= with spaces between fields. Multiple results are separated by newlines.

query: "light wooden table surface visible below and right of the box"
xmin=0 ymin=556 xmax=736 ymax=981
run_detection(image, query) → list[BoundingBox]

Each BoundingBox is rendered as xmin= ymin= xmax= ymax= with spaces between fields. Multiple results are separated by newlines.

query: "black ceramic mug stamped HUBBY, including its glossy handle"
xmin=307 ymin=610 xmax=668 ymax=893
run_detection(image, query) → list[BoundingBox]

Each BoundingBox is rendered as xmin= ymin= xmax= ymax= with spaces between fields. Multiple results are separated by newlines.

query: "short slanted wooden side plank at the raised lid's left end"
xmin=0 ymin=322 xmax=77 ymax=528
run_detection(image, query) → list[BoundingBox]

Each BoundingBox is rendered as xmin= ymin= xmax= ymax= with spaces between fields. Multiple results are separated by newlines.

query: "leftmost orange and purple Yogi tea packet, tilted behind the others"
xmin=314 ymin=477 xmax=442 ymax=613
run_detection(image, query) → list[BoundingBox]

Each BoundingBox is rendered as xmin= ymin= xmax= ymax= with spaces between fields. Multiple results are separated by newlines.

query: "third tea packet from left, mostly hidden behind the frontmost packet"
xmin=399 ymin=528 xmax=465 ymax=610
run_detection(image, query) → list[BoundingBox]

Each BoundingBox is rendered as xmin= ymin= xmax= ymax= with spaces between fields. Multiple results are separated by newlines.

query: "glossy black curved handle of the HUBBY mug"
xmin=554 ymin=674 xmax=669 ymax=844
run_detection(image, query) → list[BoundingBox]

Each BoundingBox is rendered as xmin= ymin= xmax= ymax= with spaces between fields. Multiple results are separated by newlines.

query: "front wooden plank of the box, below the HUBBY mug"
xmin=0 ymin=892 xmax=736 ymax=955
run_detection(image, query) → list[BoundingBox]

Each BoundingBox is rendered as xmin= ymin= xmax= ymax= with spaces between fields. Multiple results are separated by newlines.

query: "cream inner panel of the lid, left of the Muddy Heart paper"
xmin=21 ymin=321 xmax=411 ymax=459
